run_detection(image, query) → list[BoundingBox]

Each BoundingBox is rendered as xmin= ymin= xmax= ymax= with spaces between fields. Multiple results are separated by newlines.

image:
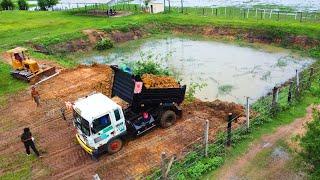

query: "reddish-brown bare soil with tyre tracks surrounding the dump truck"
xmin=0 ymin=65 xmax=243 ymax=179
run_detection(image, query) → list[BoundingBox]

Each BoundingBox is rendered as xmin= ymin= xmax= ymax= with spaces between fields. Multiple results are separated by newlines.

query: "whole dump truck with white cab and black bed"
xmin=71 ymin=66 xmax=186 ymax=158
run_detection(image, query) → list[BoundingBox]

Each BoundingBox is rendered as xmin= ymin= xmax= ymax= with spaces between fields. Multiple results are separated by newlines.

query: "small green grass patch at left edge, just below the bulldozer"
xmin=0 ymin=61 xmax=28 ymax=106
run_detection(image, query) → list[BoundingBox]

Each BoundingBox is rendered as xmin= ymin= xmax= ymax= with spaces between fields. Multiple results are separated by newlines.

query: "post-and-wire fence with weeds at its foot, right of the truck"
xmin=134 ymin=67 xmax=320 ymax=179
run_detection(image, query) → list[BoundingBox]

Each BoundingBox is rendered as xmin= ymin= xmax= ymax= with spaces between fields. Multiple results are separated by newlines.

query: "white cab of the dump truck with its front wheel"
xmin=73 ymin=93 xmax=127 ymax=156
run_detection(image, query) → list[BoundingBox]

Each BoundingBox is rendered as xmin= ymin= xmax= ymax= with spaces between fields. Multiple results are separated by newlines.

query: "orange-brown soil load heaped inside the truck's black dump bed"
xmin=141 ymin=74 xmax=180 ymax=89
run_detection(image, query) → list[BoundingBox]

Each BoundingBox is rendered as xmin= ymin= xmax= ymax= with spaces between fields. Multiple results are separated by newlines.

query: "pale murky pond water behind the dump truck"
xmin=82 ymin=38 xmax=313 ymax=103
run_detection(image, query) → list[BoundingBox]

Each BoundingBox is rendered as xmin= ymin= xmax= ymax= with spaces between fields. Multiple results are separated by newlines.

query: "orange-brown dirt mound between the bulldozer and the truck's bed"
xmin=38 ymin=65 xmax=113 ymax=101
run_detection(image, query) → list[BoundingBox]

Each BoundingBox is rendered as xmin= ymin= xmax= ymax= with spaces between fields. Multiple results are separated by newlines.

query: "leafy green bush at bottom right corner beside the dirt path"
xmin=300 ymin=110 xmax=320 ymax=178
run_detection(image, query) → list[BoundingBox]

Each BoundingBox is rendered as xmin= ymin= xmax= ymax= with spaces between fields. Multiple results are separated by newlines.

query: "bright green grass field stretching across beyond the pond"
xmin=0 ymin=11 xmax=320 ymax=51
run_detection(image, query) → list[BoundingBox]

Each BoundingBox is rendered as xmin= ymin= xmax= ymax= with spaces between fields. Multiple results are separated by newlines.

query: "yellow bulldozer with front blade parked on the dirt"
xmin=7 ymin=47 xmax=57 ymax=84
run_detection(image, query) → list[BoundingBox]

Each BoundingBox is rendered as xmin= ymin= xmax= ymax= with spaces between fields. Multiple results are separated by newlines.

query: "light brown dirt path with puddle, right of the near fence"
xmin=214 ymin=106 xmax=320 ymax=180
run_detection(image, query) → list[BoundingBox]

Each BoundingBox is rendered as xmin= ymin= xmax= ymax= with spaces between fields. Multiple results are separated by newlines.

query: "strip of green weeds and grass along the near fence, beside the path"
xmin=146 ymin=63 xmax=320 ymax=179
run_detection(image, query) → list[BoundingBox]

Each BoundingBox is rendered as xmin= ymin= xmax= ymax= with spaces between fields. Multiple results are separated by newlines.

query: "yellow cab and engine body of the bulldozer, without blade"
xmin=7 ymin=47 xmax=39 ymax=73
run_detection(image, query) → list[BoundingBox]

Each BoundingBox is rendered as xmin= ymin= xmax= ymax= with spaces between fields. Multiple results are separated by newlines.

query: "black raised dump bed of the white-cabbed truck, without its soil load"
xmin=111 ymin=66 xmax=186 ymax=111
